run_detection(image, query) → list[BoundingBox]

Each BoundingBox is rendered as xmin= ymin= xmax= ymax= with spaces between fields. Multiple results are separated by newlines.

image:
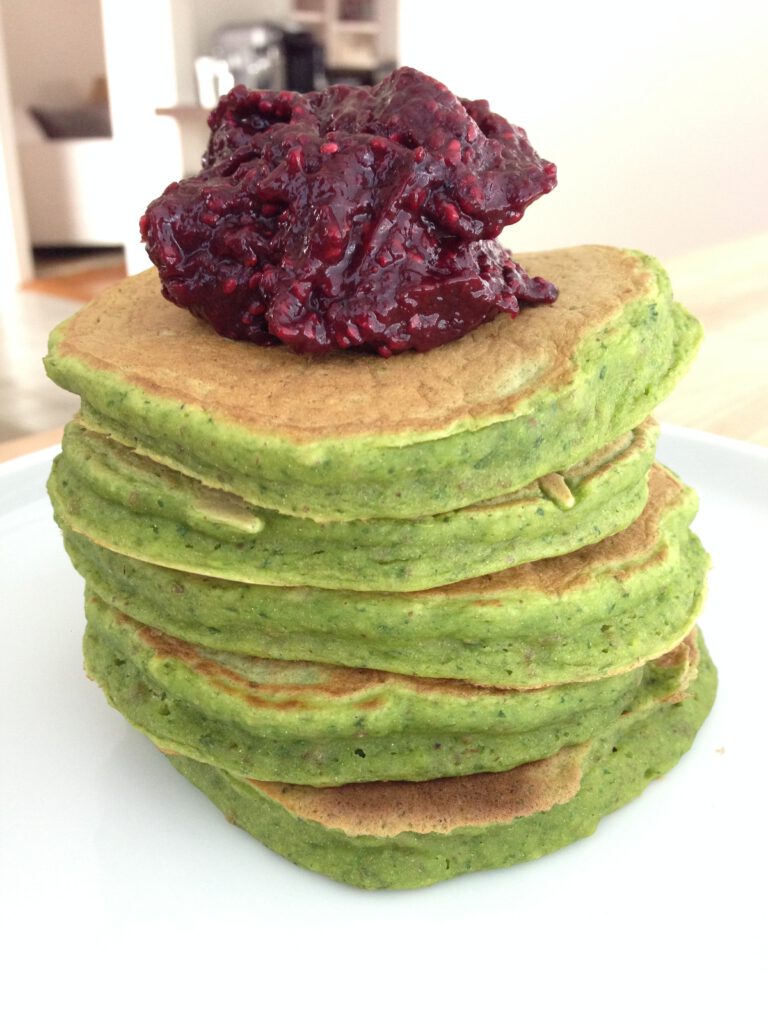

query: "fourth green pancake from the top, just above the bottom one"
xmin=85 ymin=597 xmax=695 ymax=785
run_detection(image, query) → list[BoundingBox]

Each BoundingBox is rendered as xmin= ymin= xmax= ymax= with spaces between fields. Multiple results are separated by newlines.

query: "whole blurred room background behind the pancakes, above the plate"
xmin=0 ymin=0 xmax=768 ymax=443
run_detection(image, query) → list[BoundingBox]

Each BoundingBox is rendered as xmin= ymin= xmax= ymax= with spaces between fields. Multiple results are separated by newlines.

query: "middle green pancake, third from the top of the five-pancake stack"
xmin=65 ymin=466 xmax=709 ymax=688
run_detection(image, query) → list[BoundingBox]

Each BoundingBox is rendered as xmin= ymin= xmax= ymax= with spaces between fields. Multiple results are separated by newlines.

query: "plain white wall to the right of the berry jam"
xmin=400 ymin=0 xmax=768 ymax=257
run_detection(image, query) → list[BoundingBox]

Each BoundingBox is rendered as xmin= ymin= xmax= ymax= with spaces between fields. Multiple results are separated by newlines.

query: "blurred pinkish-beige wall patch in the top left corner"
xmin=0 ymin=0 xmax=105 ymax=106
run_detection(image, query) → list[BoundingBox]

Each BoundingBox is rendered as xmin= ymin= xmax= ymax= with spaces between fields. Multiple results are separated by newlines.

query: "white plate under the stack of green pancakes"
xmin=0 ymin=428 xmax=768 ymax=1022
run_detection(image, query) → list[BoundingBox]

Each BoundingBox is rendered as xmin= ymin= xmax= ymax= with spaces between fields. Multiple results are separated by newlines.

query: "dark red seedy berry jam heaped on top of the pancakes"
xmin=141 ymin=68 xmax=557 ymax=356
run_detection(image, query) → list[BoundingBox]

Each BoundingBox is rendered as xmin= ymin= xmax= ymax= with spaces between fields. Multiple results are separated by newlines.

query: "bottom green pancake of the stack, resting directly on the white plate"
xmin=165 ymin=630 xmax=717 ymax=889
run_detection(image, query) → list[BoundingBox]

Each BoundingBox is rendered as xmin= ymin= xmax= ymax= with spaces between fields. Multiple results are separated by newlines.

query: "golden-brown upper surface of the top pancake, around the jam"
xmin=52 ymin=246 xmax=659 ymax=443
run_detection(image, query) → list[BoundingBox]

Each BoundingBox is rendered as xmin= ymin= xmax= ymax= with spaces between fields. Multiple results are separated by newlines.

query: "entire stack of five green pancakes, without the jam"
xmin=46 ymin=246 xmax=716 ymax=888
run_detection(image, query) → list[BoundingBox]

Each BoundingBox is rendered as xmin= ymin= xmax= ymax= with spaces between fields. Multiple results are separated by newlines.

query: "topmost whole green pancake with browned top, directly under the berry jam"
xmin=41 ymin=246 xmax=700 ymax=520
